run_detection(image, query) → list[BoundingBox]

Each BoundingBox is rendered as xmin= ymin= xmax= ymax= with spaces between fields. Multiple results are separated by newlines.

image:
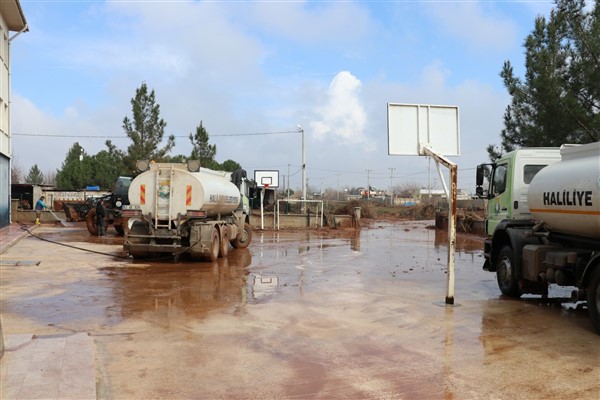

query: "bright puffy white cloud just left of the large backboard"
xmin=310 ymin=71 xmax=367 ymax=148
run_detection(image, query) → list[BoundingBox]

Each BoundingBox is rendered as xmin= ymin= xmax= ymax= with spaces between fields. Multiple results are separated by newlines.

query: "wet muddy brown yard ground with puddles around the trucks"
xmin=0 ymin=222 xmax=600 ymax=399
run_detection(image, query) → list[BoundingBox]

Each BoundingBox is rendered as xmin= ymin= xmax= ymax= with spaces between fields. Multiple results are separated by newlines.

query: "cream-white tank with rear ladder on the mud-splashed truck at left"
xmin=129 ymin=163 xmax=240 ymax=220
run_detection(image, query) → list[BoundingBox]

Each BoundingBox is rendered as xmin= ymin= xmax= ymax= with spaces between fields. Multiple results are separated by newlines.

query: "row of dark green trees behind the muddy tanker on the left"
xmin=11 ymin=82 xmax=241 ymax=190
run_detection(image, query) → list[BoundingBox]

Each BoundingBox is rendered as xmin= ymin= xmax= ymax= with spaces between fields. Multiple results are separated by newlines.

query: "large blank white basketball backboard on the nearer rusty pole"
xmin=387 ymin=103 xmax=460 ymax=156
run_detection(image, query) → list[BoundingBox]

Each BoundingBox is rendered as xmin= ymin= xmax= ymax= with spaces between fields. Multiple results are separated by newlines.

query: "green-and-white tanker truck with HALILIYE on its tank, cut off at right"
xmin=477 ymin=142 xmax=600 ymax=333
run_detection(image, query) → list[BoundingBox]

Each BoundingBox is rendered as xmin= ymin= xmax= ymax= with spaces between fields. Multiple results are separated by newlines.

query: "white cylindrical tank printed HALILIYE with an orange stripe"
xmin=527 ymin=142 xmax=600 ymax=239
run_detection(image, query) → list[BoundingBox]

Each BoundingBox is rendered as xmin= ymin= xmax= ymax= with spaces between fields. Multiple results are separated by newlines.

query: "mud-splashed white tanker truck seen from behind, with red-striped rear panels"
xmin=123 ymin=160 xmax=252 ymax=261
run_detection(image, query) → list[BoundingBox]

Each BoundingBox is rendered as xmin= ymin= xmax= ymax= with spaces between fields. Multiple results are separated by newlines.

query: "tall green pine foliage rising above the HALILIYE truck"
xmin=488 ymin=0 xmax=600 ymax=159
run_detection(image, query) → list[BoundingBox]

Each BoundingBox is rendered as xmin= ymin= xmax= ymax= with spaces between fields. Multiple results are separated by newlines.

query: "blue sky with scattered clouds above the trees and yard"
xmin=11 ymin=0 xmax=553 ymax=191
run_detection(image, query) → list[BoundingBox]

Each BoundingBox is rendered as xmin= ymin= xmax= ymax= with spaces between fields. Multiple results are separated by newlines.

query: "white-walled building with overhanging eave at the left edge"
xmin=0 ymin=0 xmax=28 ymax=228
